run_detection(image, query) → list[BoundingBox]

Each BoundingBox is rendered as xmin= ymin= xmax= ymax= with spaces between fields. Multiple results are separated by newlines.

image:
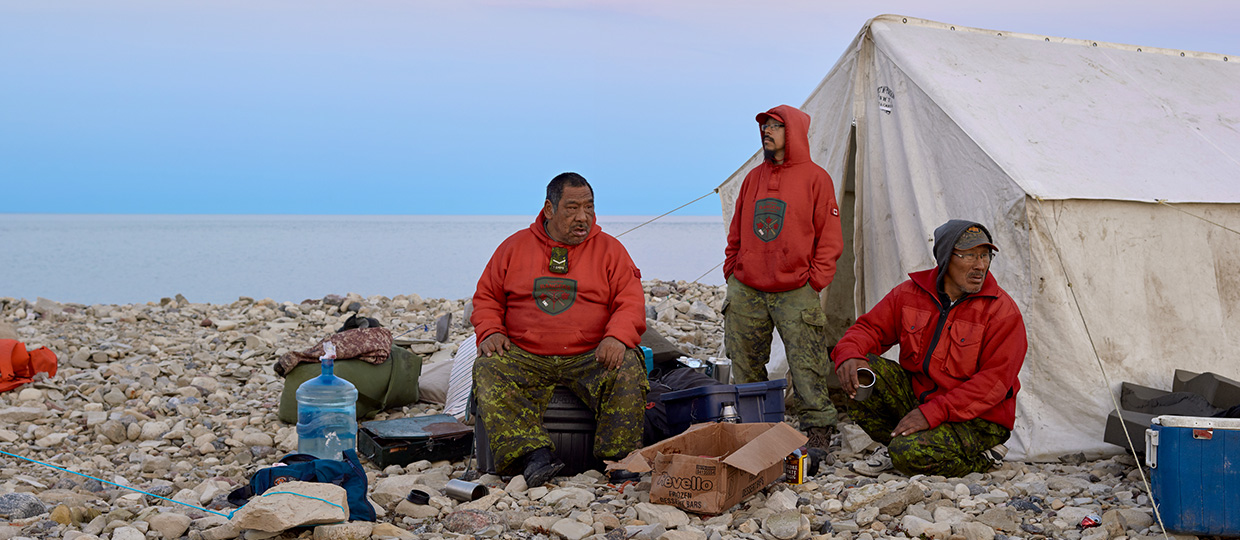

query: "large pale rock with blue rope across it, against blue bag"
xmin=233 ymin=482 xmax=348 ymax=533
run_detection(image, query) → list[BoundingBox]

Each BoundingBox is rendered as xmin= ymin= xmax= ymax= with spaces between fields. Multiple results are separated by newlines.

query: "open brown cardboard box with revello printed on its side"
xmin=608 ymin=422 xmax=808 ymax=514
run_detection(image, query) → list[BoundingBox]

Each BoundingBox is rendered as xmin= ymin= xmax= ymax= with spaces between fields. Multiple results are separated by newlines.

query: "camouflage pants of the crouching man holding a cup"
xmin=848 ymin=355 xmax=1011 ymax=477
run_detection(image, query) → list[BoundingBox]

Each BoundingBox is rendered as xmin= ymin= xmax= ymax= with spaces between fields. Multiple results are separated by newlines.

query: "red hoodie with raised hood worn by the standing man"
xmin=723 ymin=106 xmax=844 ymax=293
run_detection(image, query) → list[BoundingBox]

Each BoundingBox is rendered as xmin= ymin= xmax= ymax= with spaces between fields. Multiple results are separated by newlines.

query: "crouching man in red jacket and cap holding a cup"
xmin=832 ymin=220 xmax=1028 ymax=477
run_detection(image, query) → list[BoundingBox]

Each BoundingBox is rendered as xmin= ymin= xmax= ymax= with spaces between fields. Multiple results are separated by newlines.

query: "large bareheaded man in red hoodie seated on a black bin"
xmin=470 ymin=173 xmax=649 ymax=487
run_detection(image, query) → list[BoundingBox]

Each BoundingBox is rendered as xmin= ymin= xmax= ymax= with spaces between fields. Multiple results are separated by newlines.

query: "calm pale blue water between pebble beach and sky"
xmin=0 ymin=214 xmax=727 ymax=309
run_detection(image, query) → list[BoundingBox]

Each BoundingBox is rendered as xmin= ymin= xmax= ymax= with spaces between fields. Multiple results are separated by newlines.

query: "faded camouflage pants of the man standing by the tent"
xmin=723 ymin=277 xmax=838 ymax=430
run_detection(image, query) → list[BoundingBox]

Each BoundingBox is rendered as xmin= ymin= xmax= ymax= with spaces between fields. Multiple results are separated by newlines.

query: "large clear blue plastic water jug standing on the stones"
xmin=298 ymin=341 xmax=357 ymax=459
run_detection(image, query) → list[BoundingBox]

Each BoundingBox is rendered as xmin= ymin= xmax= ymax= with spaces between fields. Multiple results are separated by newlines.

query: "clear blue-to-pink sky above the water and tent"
xmin=0 ymin=0 xmax=1240 ymax=215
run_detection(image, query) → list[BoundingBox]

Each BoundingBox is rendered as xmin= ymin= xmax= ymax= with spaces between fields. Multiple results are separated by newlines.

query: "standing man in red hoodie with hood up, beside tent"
xmin=723 ymin=106 xmax=843 ymax=451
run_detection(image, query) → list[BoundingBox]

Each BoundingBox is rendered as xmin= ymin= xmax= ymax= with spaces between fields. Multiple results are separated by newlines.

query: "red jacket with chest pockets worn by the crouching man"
xmin=832 ymin=269 xmax=1028 ymax=430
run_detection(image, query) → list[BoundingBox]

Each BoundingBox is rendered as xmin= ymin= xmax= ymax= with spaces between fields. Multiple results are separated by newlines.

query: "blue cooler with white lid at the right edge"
xmin=1146 ymin=415 xmax=1240 ymax=536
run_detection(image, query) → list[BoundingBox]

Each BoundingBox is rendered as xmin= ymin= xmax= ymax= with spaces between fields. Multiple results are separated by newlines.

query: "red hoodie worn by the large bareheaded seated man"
xmin=470 ymin=212 xmax=646 ymax=356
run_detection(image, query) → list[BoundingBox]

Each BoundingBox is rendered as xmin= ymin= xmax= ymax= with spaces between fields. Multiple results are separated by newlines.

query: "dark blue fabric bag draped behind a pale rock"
xmin=228 ymin=449 xmax=374 ymax=521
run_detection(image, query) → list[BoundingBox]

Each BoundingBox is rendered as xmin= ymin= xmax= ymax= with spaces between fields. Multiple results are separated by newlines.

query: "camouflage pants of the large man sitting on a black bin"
xmin=474 ymin=345 xmax=649 ymax=473
